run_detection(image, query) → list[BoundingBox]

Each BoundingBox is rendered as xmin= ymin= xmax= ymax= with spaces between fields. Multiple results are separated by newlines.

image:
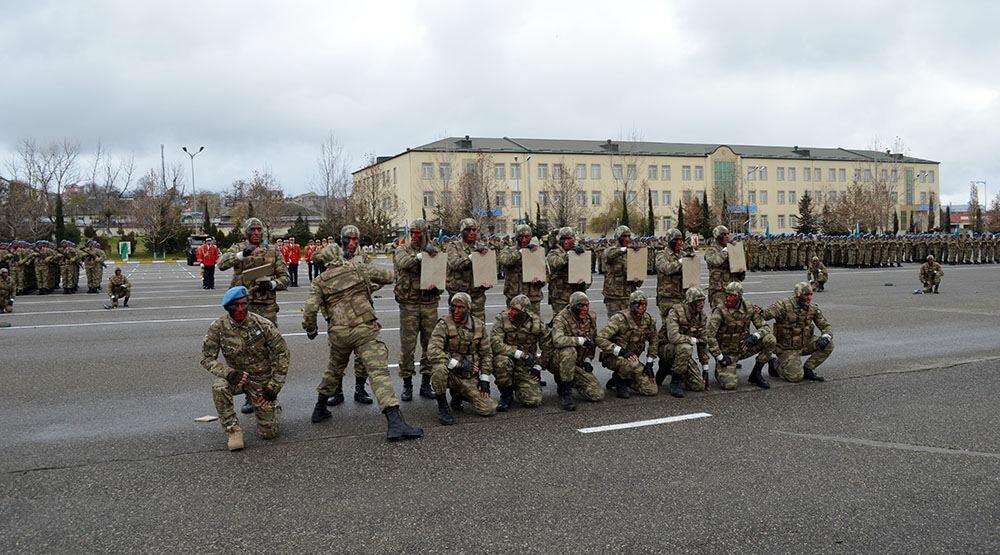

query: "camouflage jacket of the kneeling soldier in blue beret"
xmin=201 ymin=312 xmax=289 ymax=393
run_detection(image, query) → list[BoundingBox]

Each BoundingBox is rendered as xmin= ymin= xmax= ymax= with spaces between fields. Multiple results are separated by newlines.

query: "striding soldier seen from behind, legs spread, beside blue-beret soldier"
xmin=302 ymin=245 xmax=424 ymax=441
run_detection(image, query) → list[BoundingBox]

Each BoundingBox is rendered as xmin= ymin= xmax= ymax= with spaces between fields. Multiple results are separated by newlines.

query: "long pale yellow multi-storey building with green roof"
xmin=353 ymin=136 xmax=941 ymax=237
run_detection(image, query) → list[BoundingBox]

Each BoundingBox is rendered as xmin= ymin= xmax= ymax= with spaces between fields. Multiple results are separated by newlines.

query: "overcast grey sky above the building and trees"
xmin=0 ymin=0 xmax=1000 ymax=203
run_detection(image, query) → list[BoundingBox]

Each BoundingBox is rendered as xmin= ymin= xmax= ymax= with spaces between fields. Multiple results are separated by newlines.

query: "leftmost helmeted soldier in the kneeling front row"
xmin=428 ymin=292 xmax=497 ymax=426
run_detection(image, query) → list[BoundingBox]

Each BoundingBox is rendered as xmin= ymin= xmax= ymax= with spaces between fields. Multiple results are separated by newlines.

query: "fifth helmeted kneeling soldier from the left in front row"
xmin=656 ymin=287 xmax=708 ymax=397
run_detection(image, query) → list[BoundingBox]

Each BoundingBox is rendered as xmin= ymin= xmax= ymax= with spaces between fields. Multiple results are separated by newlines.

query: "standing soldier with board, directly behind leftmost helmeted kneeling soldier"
xmin=393 ymin=220 xmax=441 ymax=401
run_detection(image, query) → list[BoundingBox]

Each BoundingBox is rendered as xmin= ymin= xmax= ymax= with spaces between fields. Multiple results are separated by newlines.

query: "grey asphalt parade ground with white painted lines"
xmin=0 ymin=263 xmax=1000 ymax=553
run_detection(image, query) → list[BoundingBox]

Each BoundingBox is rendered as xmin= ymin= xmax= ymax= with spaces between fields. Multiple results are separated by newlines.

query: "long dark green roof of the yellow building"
xmin=354 ymin=135 xmax=939 ymax=173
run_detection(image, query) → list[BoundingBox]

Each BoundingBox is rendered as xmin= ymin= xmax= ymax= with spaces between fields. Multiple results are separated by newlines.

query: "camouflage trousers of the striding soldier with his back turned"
xmin=316 ymin=324 xmax=399 ymax=410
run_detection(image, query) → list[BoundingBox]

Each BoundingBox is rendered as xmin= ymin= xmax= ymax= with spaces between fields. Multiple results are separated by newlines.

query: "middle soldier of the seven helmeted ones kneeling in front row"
xmin=597 ymin=291 xmax=658 ymax=399
